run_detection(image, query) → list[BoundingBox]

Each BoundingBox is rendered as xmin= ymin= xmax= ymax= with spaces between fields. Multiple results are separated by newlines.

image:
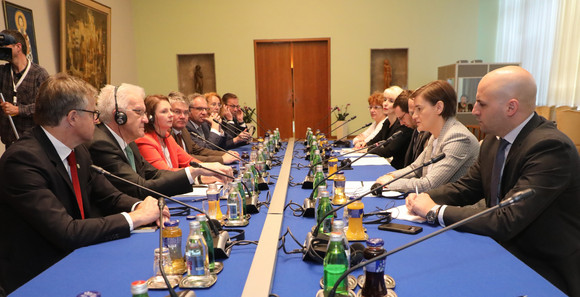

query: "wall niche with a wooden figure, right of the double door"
xmin=370 ymin=48 xmax=409 ymax=94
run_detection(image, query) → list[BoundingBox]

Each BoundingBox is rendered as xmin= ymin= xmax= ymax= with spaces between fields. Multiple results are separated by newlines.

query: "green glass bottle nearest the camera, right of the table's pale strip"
xmin=323 ymin=232 xmax=349 ymax=296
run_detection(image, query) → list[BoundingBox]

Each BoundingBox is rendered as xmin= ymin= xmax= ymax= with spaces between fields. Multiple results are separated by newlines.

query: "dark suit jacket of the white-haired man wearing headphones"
xmin=86 ymin=124 xmax=192 ymax=199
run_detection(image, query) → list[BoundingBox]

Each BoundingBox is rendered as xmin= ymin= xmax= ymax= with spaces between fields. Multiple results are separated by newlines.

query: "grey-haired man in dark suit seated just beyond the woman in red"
xmin=168 ymin=92 xmax=239 ymax=164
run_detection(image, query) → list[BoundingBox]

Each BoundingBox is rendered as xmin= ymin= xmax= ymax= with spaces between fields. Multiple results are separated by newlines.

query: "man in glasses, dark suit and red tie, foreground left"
xmin=0 ymin=74 xmax=169 ymax=294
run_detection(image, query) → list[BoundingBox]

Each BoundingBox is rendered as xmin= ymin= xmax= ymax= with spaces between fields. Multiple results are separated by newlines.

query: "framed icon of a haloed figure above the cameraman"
xmin=2 ymin=1 xmax=38 ymax=64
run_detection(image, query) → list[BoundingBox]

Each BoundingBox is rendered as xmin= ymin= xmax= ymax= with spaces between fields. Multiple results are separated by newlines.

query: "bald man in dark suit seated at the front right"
xmin=407 ymin=66 xmax=580 ymax=296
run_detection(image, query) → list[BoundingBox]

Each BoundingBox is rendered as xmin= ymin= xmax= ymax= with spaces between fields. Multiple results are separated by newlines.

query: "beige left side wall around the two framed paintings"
xmin=0 ymin=0 xmax=137 ymax=84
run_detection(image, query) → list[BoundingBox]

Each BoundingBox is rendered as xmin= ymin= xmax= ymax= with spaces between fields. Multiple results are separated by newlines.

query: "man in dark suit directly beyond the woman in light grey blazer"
xmin=393 ymin=92 xmax=431 ymax=168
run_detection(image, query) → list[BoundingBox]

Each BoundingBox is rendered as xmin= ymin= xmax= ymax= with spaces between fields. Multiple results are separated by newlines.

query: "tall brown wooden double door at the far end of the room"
xmin=254 ymin=39 xmax=330 ymax=138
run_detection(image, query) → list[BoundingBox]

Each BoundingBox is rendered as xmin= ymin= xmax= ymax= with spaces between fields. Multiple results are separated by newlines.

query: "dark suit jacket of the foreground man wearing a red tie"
xmin=0 ymin=126 xmax=140 ymax=293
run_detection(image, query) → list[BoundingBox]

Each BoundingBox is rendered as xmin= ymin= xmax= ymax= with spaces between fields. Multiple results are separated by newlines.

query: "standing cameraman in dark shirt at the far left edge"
xmin=0 ymin=30 xmax=48 ymax=148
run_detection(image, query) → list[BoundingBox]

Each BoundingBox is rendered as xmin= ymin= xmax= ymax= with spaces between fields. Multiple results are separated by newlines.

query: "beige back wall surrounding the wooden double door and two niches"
xmin=133 ymin=0 xmax=497 ymax=135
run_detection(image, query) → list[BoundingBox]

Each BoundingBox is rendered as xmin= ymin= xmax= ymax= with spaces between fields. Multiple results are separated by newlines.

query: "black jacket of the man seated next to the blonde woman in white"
xmin=369 ymin=119 xmax=413 ymax=169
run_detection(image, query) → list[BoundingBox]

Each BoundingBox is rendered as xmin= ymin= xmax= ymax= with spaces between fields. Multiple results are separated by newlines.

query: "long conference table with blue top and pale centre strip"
xmin=9 ymin=139 xmax=565 ymax=297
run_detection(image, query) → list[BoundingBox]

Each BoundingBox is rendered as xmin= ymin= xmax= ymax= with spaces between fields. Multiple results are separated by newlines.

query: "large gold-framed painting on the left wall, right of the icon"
xmin=60 ymin=0 xmax=111 ymax=89
